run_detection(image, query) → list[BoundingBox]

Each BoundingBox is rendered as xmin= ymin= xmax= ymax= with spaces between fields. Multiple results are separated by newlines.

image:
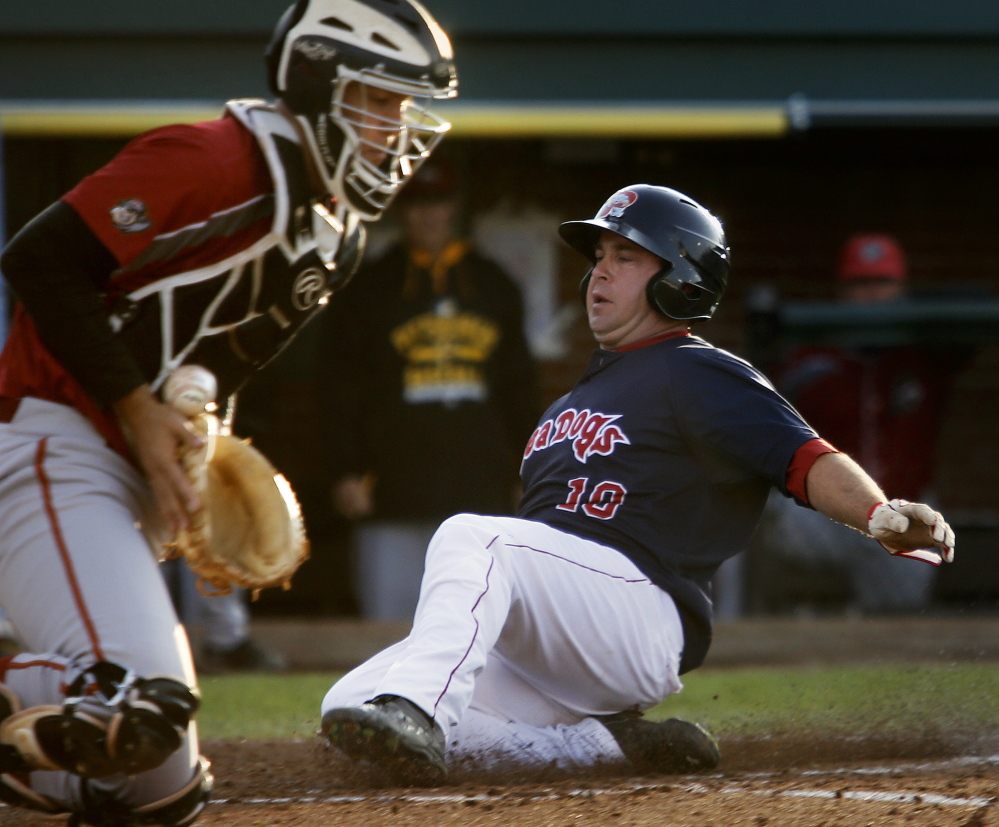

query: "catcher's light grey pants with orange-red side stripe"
xmin=0 ymin=399 xmax=198 ymax=808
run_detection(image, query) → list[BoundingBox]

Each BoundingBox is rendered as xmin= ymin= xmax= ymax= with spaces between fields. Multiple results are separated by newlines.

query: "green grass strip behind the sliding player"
xmin=198 ymin=664 xmax=999 ymax=740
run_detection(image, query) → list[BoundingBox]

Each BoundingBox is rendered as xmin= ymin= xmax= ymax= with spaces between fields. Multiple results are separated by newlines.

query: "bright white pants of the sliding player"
xmin=322 ymin=514 xmax=683 ymax=770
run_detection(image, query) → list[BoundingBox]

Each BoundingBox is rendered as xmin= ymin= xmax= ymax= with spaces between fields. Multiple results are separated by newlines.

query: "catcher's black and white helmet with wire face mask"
xmin=266 ymin=0 xmax=458 ymax=220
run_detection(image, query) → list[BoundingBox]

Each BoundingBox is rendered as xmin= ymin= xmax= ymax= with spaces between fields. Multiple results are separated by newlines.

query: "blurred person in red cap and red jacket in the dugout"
xmin=755 ymin=233 xmax=963 ymax=614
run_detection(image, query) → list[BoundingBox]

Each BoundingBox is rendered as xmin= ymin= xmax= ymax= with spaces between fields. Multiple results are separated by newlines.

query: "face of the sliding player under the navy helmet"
xmin=586 ymin=230 xmax=676 ymax=350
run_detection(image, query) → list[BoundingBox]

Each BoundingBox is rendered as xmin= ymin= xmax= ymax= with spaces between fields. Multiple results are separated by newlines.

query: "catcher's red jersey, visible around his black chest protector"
xmin=0 ymin=116 xmax=273 ymax=455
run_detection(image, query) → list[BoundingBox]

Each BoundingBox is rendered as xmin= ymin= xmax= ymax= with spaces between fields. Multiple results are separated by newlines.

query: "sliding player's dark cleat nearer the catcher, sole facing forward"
xmin=322 ymin=695 xmax=447 ymax=787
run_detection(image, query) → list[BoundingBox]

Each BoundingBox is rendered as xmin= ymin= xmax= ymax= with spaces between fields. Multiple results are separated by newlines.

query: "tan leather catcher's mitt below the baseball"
xmin=167 ymin=413 xmax=309 ymax=597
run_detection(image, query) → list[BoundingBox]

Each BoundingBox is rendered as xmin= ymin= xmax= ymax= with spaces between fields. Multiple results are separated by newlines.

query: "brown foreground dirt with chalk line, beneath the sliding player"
xmin=7 ymin=734 xmax=999 ymax=827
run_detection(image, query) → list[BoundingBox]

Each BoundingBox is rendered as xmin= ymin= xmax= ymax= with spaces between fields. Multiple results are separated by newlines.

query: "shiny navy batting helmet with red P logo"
xmin=559 ymin=184 xmax=729 ymax=320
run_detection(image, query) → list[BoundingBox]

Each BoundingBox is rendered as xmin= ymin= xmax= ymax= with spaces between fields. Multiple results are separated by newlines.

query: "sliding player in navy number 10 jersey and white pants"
xmin=322 ymin=184 xmax=954 ymax=784
